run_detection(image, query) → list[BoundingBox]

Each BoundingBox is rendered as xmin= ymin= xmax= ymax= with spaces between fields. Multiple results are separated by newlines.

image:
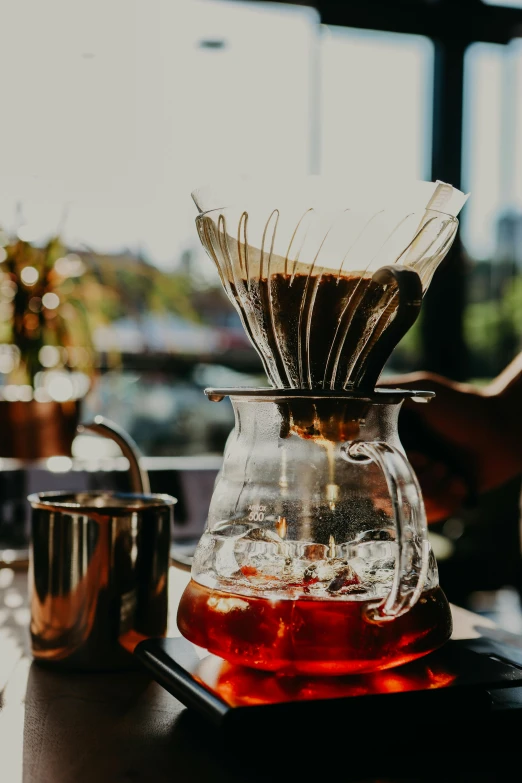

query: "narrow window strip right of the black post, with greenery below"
xmin=461 ymin=40 xmax=522 ymax=382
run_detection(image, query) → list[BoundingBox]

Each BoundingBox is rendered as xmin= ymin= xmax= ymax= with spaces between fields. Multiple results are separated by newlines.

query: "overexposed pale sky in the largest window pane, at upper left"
xmin=0 ymin=0 xmax=318 ymax=269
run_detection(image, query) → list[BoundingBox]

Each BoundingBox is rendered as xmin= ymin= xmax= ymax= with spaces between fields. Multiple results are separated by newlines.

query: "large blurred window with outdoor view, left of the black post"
xmin=0 ymin=0 xmax=433 ymax=455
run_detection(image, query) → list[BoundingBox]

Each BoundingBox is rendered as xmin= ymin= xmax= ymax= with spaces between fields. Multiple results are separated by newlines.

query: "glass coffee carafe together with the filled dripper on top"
xmin=177 ymin=175 xmax=466 ymax=675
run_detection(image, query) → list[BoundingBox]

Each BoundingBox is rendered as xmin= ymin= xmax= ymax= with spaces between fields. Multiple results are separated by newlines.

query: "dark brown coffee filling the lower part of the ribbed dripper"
xmin=238 ymin=273 xmax=398 ymax=389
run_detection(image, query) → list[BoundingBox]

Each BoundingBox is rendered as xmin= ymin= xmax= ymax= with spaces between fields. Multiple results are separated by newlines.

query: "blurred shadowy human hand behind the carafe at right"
xmin=379 ymin=372 xmax=522 ymax=522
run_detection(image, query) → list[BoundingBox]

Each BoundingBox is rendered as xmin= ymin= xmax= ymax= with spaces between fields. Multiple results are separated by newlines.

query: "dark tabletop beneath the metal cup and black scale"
xmin=0 ymin=568 xmax=522 ymax=783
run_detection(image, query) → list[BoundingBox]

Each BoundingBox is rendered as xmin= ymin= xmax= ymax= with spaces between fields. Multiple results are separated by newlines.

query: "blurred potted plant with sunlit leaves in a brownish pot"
xmin=0 ymin=232 xmax=96 ymax=460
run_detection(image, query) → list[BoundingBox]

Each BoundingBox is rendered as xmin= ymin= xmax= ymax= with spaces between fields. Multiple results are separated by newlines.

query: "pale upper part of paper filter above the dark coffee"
xmin=192 ymin=177 xmax=468 ymax=284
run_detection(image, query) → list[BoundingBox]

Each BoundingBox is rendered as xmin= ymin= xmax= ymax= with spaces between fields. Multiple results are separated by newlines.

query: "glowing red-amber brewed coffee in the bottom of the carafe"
xmin=177 ymin=579 xmax=452 ymax=675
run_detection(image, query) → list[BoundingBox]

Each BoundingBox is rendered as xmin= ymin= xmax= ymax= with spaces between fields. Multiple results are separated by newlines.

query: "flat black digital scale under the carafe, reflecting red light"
xmin=134 ymin=637 xmax=522 ymax=728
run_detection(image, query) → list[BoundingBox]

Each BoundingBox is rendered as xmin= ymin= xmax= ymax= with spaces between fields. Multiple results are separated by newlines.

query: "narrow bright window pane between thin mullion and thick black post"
xmin=321 ymin=27 xmax=433 ymax=184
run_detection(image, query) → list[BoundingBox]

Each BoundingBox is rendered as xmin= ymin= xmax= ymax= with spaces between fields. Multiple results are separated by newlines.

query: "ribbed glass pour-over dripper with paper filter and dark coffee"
xmin=192 ymin=177 xmax=467 ymax=389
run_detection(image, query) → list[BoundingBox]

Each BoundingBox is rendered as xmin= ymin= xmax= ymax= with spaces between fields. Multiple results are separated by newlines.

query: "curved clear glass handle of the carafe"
xmin=344 ymin=441 xmax=426 ymax=622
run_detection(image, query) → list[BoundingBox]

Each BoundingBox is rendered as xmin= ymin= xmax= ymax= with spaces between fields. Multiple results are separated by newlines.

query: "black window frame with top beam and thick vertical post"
xmin=242 ymin=0 xmax=522 ymax=380
